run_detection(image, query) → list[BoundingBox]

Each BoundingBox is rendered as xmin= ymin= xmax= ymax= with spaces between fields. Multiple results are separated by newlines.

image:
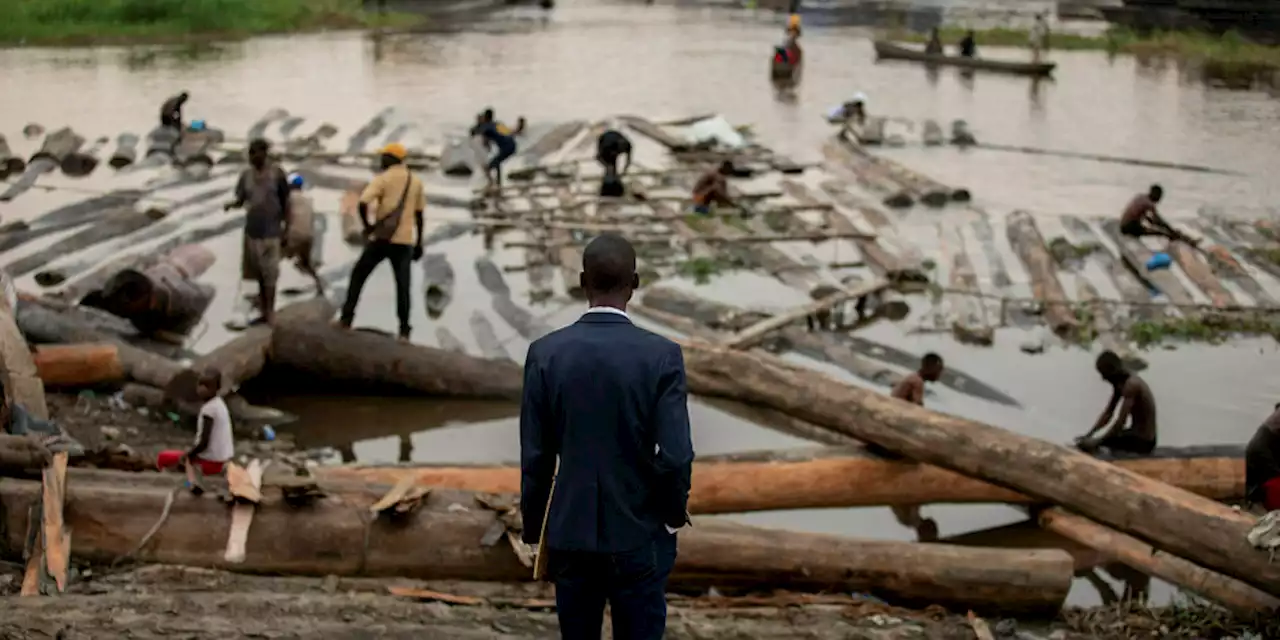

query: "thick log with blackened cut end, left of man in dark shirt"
xmin=84 ymin=244 xmax=215 ymax=335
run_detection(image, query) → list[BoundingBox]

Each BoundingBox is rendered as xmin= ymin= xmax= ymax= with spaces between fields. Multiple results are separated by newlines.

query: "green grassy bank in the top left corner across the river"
xmin=0 ymin=0 xmax=411 ymax=45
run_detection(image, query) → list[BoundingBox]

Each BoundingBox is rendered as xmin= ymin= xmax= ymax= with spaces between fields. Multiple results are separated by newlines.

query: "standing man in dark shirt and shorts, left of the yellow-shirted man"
xmin=224 ymin=138 xmax=289 ymax=324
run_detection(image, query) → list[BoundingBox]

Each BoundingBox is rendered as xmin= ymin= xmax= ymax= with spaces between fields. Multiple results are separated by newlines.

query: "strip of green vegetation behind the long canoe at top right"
xmin=888 ymin=27 xmax=1280 ymax=68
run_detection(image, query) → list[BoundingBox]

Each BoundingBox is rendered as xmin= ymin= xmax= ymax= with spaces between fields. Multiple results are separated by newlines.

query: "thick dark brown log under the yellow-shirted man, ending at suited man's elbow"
xmin=271 ymin=314 xmax=522 ymax=401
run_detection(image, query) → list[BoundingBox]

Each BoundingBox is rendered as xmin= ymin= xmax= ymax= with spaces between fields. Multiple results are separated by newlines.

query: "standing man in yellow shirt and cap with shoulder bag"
xmin=338 ymin=143 xmax=426 ymax=342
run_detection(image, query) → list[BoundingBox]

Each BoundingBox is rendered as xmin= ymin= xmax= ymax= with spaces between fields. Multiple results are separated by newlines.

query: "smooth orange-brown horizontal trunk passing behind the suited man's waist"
xmin=316 ymin=447 xmax=1244 ymax=515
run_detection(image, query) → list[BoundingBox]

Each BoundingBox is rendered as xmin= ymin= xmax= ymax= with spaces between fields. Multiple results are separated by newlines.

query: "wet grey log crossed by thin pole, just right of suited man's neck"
xmin=643 ymin=287 xmax=902 ymax=387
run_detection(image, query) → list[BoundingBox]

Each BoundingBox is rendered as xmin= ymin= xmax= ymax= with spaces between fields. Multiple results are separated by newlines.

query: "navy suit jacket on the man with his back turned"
xmin=520 ymin=311 xmax=694 ymax=553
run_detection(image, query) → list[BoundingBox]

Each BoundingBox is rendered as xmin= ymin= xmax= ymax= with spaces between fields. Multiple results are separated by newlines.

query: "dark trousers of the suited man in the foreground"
xmin=547 ymin=530 xmax=676 ymax=640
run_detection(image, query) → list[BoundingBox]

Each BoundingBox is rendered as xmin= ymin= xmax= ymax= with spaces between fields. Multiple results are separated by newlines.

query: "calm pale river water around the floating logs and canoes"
xmin=0 ymin=0 xmax=1280 ymax=604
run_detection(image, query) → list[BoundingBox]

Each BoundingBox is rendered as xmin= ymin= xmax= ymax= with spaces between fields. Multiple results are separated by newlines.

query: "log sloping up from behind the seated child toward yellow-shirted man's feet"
xmin=156 ymin=291 xmax=342 ymax=402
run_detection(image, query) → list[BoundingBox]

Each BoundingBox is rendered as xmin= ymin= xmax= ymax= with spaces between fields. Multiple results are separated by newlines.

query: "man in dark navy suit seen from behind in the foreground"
xmin=520 ymin=236 xmax=694 ymax=640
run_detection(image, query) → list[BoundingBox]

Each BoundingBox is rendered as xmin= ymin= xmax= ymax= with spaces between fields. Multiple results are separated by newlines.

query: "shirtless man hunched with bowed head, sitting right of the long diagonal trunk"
xmin=1075 ymin=351 xmax=1156 ymax=454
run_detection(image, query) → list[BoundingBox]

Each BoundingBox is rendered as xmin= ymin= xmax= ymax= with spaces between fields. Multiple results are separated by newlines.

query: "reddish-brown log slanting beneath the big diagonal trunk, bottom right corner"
xmin=1039 ymin=508 xmax=1280 ymax=620
